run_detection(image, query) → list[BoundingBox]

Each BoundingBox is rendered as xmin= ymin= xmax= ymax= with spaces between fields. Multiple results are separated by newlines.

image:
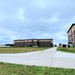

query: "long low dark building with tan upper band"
xmin=14 ymin=39 xmax=53 ymax=47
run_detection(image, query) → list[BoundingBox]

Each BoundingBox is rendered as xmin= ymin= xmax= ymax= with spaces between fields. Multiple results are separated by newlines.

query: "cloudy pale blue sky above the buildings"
xmin=0 ymin=0 xmax=75 ymax=44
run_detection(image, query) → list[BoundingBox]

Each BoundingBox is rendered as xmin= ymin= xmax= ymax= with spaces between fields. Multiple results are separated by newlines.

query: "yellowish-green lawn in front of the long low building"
xmin=0 ymin=47 xmax=50 ymax=53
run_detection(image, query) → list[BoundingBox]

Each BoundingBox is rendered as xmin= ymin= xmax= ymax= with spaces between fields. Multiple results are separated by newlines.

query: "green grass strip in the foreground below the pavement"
xmin=0 ymin=63 xmax=75 ymax=75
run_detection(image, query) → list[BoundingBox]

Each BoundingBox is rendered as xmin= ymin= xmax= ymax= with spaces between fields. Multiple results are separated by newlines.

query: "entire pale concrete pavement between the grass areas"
xmin=0 ymin=47 xmax=75 ymax=69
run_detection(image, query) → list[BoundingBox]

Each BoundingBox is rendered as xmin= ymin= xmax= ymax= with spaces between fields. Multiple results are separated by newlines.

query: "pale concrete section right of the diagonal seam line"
xmin=51 ymin=51 xmax=75 ymax=69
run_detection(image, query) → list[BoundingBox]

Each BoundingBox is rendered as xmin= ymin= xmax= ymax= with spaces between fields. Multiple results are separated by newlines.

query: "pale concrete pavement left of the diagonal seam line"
xmin=0 ymin=48 xmax=56 ymax=66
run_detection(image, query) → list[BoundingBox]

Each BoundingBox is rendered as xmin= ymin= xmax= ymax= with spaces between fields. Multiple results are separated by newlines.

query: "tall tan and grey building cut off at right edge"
xmin=67 ymin=23 xmax=75 ymax=46
